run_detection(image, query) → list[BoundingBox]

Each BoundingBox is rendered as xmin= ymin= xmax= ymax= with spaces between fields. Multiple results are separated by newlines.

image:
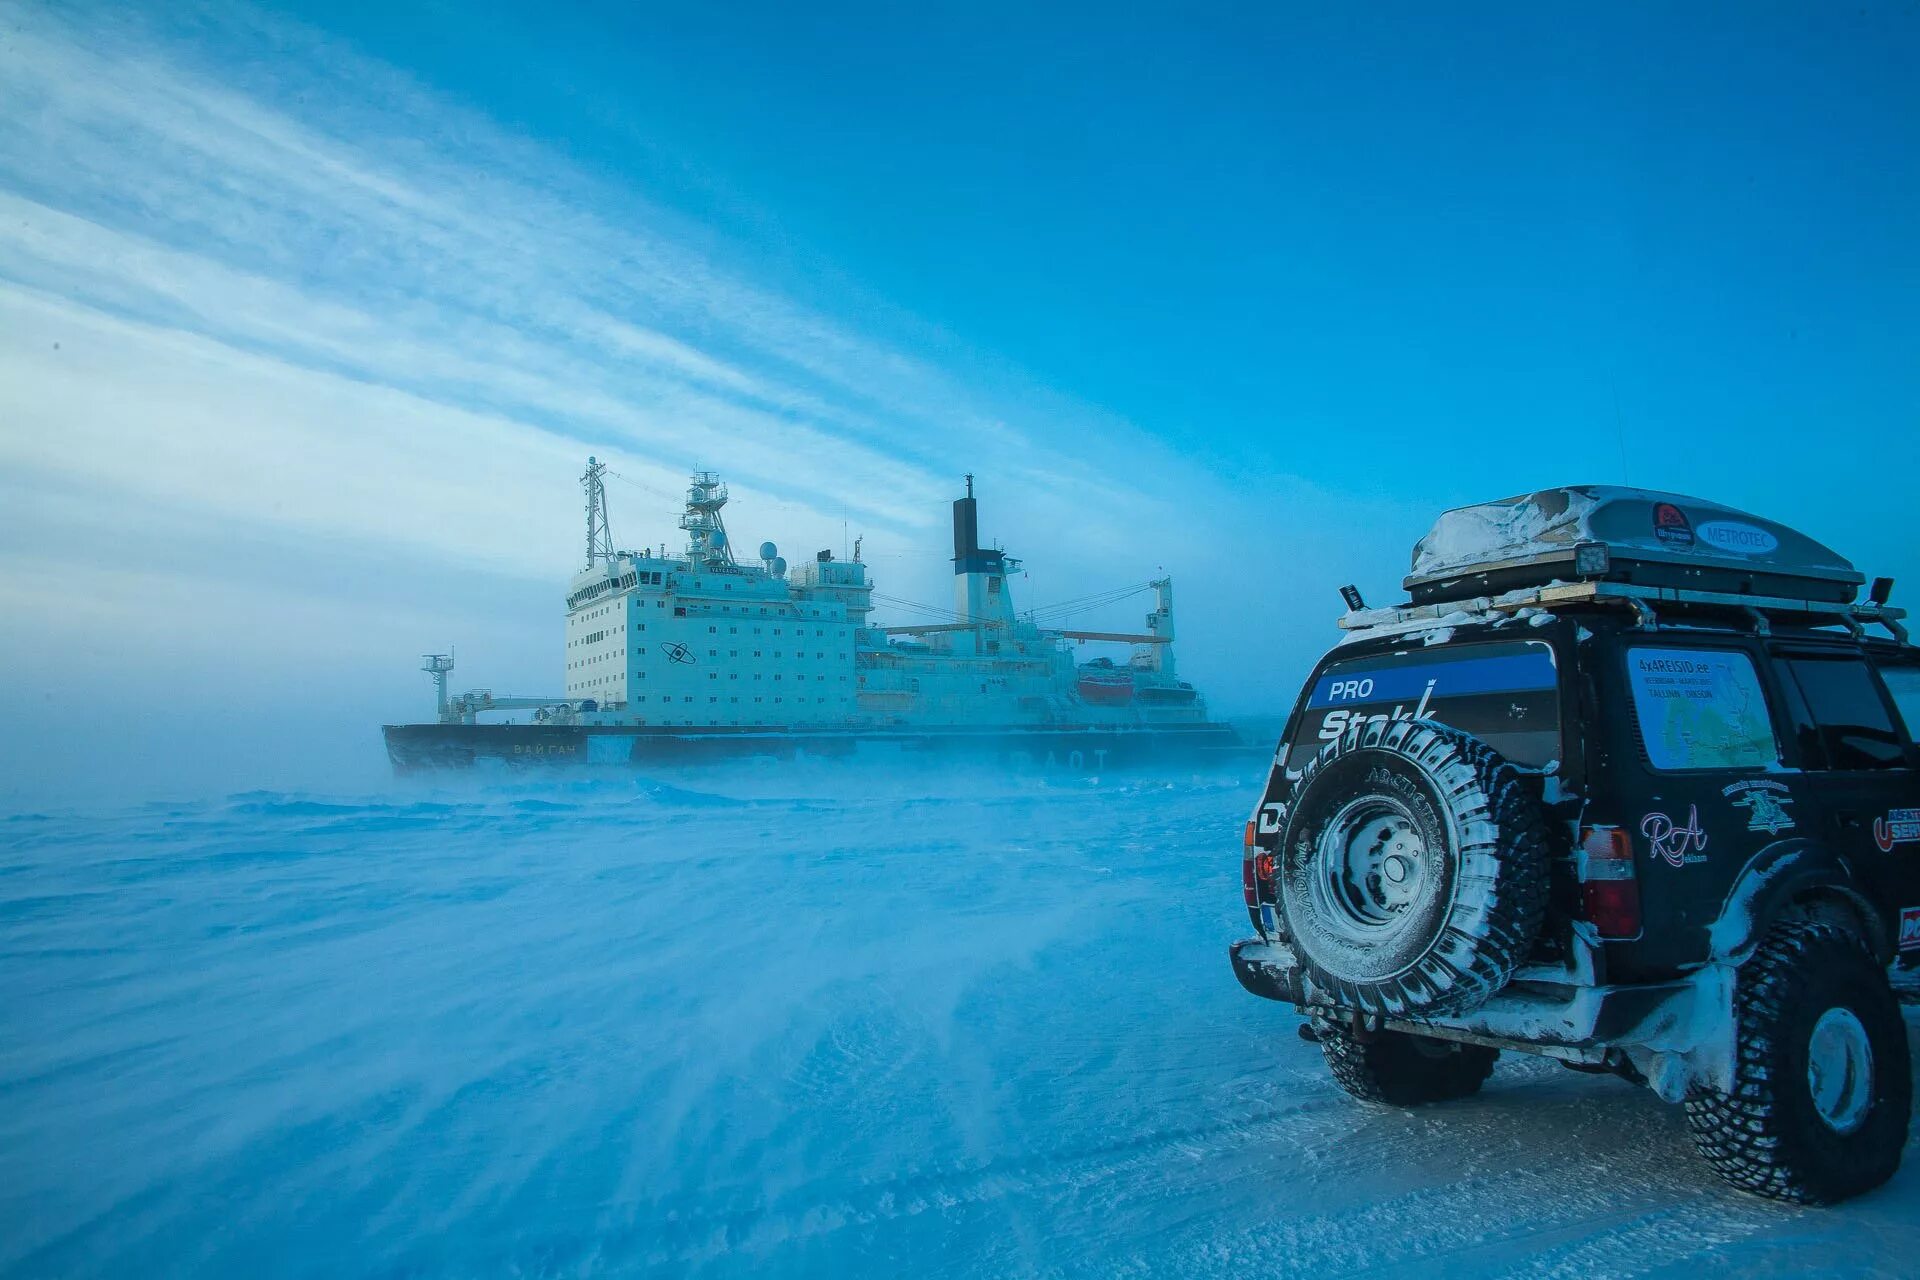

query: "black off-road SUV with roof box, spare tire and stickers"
xmin=1231 ymin=486 xmax=1920 ymax=1203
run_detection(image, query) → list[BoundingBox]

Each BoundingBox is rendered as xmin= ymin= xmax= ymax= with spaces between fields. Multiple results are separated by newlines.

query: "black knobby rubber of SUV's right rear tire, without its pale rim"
xmin=1686 ymin=921 xmax=1912 ymax=1205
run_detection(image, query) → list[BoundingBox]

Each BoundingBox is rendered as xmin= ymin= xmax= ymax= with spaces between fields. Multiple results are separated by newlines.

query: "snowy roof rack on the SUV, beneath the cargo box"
xmin=1340 ymin=581 xmax=1910 ymax=645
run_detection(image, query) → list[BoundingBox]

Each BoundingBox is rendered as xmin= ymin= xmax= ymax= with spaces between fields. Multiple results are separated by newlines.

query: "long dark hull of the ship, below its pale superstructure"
xmin=382 ymin=723 xmax=1261 ymax=773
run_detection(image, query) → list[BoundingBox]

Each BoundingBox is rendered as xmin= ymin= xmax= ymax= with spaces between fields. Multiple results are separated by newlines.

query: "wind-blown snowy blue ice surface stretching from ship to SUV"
xmin=0 ymin=768 xmax=1920 ymax=1278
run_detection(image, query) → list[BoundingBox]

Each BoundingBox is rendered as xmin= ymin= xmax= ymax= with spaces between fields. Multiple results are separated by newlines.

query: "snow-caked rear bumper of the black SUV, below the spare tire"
xmin=1229 ymin=938 xmax=1734 ymax=1102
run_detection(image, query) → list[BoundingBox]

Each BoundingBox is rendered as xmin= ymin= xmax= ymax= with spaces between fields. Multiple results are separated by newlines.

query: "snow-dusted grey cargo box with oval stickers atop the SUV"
xmin=1404 ymin=484 xmax=1864 ymax=604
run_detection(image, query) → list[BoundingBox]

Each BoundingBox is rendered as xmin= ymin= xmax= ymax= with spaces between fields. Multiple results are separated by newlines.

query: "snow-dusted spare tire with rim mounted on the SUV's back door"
xmin=1275 ymin=720 xmax=1548 ymax=1017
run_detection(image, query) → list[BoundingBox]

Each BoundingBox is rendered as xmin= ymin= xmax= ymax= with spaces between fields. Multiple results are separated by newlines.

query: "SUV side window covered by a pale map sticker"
xmin=1626 ymin=649 xmax=1780 ymax=770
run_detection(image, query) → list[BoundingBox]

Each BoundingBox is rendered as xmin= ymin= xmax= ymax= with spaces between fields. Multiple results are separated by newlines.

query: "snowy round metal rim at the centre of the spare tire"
xmin=1311 ymin=796 xmax=1428 ymax=942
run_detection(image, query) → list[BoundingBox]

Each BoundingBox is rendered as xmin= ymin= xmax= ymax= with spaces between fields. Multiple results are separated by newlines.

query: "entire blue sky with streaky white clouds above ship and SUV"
xmin=0 ymin=4 xmax=1920 ymax=802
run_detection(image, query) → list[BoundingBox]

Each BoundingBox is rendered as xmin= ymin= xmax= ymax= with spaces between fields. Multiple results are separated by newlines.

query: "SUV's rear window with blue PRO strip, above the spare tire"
xmin=1286 ymin=641 xmax=1561 ymax=768
